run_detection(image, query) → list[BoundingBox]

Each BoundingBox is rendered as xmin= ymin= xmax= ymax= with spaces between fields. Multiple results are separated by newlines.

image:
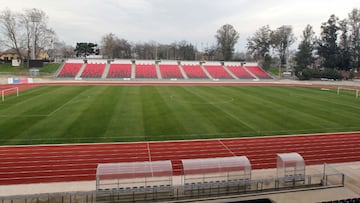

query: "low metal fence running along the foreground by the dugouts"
xmin=0 ymin=164 xmax=345 ymax=203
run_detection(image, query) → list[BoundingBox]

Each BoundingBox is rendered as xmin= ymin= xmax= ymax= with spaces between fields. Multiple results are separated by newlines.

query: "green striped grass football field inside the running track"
xmin=0 ymin=86 xmax=360 ymax=145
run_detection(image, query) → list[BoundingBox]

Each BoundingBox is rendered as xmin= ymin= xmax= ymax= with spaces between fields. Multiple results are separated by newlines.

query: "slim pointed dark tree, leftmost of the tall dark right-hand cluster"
xmin=295 ymin=25 xmax=316 ymax=74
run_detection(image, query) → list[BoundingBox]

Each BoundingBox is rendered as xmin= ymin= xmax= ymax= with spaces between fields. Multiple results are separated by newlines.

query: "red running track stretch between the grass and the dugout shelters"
xmin=0 ymin=132 xmax=360 ymax=185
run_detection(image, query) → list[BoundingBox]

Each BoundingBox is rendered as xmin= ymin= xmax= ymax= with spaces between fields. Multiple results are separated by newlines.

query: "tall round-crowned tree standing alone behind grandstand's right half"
xmin=215 ymin=24 xmax=239 ymax=61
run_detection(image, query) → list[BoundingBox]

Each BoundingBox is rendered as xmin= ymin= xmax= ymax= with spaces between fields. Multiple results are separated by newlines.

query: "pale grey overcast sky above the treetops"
xmin=0 ymin=0 xmax=360 ymax=51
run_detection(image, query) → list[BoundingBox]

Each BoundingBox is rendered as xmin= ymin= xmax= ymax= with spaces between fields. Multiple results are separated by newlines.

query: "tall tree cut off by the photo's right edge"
xmin=348 ymin=9 xmax=360 ymax=71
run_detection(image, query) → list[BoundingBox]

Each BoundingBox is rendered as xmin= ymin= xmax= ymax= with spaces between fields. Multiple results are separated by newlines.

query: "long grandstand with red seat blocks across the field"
xmin=56 ymin=59 xmax=272 ymax=80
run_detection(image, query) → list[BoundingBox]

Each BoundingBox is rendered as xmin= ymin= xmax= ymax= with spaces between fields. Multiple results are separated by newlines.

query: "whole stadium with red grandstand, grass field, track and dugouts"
xmin=0 ymin=59 xmax=360 ymax=203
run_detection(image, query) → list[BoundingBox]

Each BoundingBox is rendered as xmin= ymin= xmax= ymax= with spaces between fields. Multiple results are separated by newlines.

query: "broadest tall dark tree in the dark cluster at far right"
xmin=317 ymin=15 xmax=339 ymax=69
